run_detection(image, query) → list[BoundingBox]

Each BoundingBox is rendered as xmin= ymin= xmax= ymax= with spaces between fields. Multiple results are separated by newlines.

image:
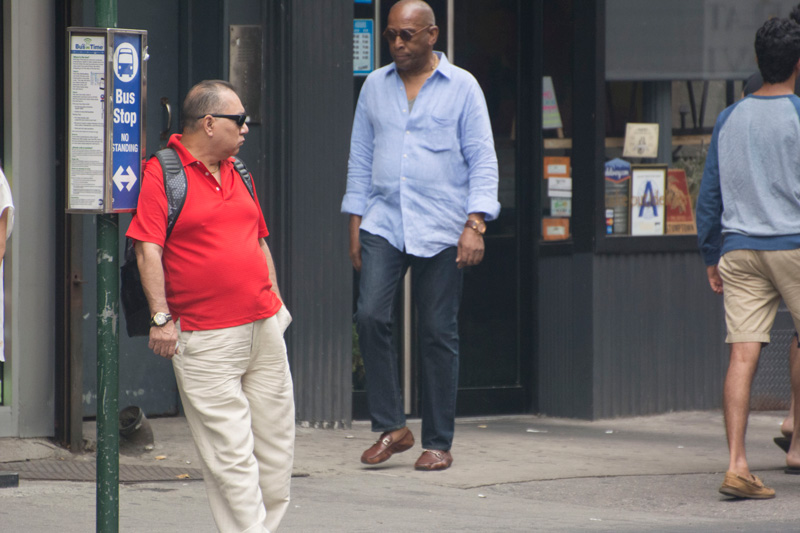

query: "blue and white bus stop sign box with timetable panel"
xmin=67 ymin=28 xmax=147 ymax=213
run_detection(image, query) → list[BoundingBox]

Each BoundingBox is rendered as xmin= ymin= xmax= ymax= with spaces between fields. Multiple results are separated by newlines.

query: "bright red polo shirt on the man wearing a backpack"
xmin=126 ymin=135 xmax=281 ymax=331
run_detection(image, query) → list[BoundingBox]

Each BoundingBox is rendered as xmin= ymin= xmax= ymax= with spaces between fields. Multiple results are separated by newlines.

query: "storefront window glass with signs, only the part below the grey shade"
xmin=604 ymin=80 xmax=742 ymax=237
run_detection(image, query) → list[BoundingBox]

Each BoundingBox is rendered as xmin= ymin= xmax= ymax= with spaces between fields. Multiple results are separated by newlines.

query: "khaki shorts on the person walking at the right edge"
xmin=719 ymin=249 xmax=800 ymax=343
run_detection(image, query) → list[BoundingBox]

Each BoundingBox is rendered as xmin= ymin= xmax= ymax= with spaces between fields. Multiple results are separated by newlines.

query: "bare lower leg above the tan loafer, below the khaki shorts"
xmin=723 ymin=342 xmax=764 ymax=479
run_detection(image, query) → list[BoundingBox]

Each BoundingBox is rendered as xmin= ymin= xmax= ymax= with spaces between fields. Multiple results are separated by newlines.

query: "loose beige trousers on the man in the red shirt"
xmin=172 ymin=308 xmax=295 ymax=533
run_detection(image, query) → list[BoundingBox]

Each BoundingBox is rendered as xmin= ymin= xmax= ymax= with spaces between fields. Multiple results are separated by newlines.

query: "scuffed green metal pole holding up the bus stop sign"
xmin=95 ymin=0 xmax=119 ymax=533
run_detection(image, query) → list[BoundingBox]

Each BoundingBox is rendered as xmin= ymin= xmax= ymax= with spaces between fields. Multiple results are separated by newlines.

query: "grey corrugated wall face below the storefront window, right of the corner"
xmin=593 ymin=252 xmax=728 ymax=418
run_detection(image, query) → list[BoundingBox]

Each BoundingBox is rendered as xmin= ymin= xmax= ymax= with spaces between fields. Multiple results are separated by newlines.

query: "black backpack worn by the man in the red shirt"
xmin=120 ymin=148 xmax=255 ymax=337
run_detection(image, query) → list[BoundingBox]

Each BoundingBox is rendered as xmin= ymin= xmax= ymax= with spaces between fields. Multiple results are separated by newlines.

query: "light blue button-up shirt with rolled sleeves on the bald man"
xmin=342 ymin=52 xmax=500 ymax=257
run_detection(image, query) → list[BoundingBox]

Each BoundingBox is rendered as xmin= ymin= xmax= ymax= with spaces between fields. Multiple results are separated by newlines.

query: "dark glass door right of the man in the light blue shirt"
xmin=450 ymin=0 xmax=527 ymax=415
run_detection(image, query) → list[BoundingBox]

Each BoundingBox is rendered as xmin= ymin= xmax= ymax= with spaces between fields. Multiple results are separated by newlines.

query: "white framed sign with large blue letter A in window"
xmin=629 ymin=165 xmax=667 ymax=236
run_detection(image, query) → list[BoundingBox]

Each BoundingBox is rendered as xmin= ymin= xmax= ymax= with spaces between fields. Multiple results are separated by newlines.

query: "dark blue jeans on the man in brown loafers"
xmin=356 ymin=231 xmax=463 ymax=450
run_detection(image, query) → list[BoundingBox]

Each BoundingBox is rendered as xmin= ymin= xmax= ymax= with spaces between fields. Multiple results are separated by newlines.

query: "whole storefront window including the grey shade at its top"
xmin=602 ymin=0 xmax=772 ymax=242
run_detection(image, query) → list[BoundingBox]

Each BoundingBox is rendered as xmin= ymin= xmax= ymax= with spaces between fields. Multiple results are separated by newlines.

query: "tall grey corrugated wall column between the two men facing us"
xmin=282 ymin=0 xmax=353 ymax=427
